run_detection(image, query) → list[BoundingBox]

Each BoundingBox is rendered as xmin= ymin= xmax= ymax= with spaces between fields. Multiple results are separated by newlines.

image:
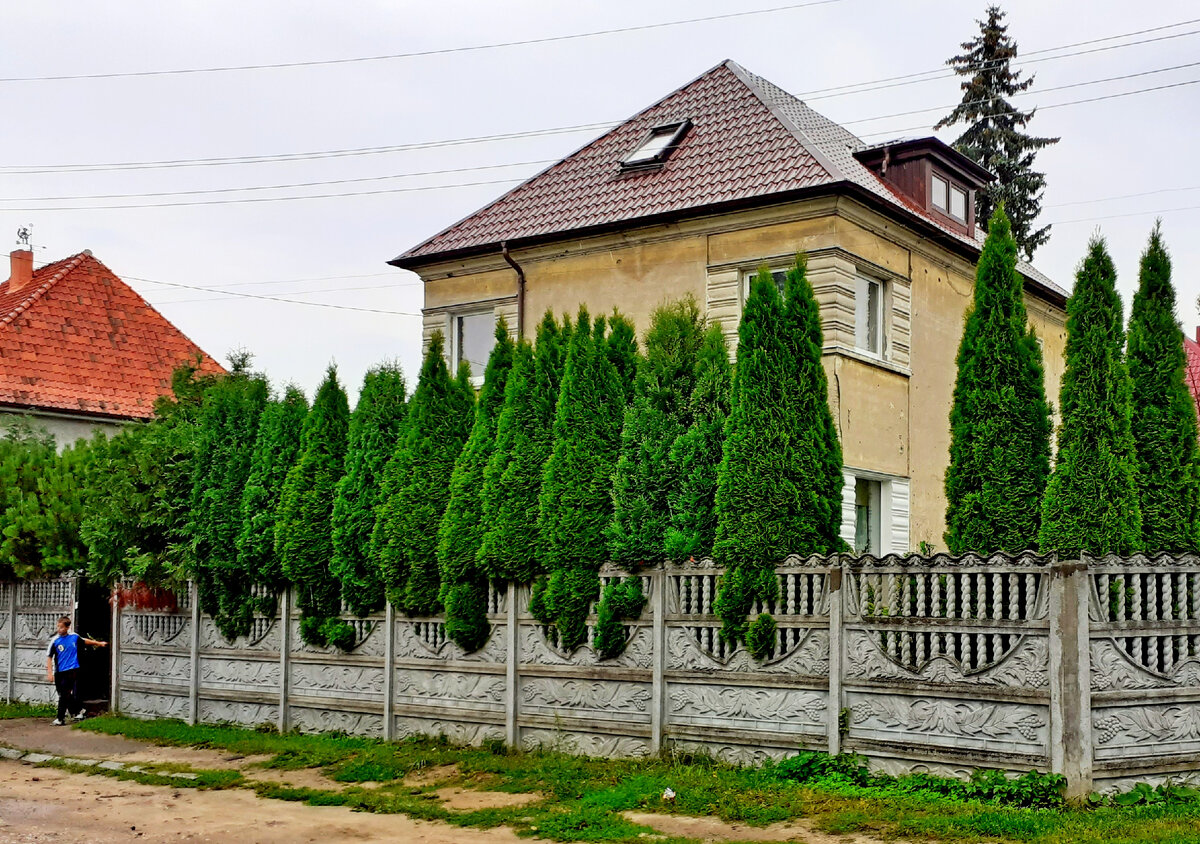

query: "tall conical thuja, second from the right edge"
xmin=1040 ymin=237 xmax=1141 ymax=557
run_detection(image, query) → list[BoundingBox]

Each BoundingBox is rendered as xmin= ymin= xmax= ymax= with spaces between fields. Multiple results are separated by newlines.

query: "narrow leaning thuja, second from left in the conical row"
xmin=238 ymin=385 xmax=308 ymax=605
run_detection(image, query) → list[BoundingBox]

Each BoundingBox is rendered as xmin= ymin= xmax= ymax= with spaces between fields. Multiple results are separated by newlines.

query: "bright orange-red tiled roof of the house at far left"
xmin=0 ymin=252 xmax=223 ymax=419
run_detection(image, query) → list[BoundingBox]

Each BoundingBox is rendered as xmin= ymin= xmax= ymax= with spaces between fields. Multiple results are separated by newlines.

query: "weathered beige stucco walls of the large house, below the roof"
xmin=419 ymin=197 xmax=1066 ymax=551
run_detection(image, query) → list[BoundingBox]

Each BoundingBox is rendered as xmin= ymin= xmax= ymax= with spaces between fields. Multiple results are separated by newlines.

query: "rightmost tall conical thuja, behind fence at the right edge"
xmin=1128 ymin=225 xmax=1200 ymax=553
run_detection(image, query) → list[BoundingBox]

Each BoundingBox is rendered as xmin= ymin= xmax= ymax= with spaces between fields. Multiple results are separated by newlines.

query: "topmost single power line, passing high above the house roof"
xmin=0 ymin=0 xmax=842 ymax=83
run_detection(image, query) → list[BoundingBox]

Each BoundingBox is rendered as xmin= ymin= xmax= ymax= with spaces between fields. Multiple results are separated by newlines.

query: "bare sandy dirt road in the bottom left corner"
xmin=0 ymin=760 xmax=530 ymax=844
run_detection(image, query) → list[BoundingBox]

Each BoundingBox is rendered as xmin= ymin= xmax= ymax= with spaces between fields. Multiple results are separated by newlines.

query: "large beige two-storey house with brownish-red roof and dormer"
xmin=390 ymin=61 xmax=1067 ymax=552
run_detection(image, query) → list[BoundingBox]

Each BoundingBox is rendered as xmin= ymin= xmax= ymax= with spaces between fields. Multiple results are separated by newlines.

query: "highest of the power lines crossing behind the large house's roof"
xmin=0 ymin=18 xmax=1200 ymax=175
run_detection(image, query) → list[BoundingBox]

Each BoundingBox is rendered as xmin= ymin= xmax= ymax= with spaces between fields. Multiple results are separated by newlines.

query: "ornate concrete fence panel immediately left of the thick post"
xmin=842 ymin=555 xmax=1050 ymax=773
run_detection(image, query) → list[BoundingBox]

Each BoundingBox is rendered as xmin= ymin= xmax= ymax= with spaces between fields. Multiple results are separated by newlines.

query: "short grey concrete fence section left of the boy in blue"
xmin=0 ymin=577 xmax=77 ymax=704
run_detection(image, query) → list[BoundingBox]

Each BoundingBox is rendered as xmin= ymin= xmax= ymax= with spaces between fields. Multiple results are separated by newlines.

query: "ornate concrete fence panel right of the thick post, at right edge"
xmin=1086 ymin=555 xmax=1200 ymax=789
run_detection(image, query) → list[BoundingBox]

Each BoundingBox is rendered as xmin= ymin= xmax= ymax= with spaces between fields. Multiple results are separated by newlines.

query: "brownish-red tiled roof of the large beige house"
xmin=391 ymin=61 xmax=1066 ymax=303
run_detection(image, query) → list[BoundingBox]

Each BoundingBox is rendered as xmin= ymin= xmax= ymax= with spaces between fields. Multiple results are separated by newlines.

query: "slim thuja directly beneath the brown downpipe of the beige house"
xmin=479 ymin=311 xmax=571 ymax=583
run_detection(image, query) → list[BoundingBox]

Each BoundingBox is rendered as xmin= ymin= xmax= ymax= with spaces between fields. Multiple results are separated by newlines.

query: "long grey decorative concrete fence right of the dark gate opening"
xmin=63 ymin=555 xmax=1200 ymax=796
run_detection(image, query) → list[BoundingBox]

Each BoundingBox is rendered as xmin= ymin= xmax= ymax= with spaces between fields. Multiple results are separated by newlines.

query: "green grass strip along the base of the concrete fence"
xmin=80 ymin=716 xmax=1200 ymax=844
